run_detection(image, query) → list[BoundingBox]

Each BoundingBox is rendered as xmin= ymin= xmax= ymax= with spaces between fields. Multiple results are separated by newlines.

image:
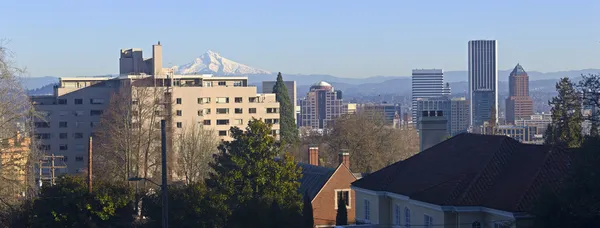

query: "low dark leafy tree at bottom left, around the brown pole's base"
xmin=31 ymin=176 xmax=134 ymax=227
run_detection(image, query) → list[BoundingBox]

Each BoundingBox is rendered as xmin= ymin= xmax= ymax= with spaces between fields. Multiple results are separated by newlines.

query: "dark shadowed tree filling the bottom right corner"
xmin=532 ymin=137 xmax=600 ymax=228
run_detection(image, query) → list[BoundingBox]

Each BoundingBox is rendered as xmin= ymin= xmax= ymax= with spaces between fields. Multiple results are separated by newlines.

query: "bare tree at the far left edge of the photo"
xmin=0 ymin=40 xmax=41 ymax=211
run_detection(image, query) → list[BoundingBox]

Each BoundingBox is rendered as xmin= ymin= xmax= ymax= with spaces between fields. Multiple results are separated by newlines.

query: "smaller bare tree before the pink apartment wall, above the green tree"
xmin=174 ymin=124 xmax=219 ymax=183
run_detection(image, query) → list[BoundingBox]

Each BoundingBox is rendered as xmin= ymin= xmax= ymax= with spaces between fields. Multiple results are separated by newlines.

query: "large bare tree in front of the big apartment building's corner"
xmin=94 ymin=81 xmax=172 ymax=183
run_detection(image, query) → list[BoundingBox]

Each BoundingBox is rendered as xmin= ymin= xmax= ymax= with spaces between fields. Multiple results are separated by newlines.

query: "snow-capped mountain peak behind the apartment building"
xmin=174 ymin=50 xmax=271 ymax=75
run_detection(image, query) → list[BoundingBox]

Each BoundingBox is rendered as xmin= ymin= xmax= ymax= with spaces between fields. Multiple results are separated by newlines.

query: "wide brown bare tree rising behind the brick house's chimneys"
xmin=298 ymin=112 xmax=419 ymax=172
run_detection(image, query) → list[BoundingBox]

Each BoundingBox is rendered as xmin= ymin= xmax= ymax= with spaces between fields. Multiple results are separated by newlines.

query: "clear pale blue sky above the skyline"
xmin=0 ymin=0 xmax=600 ymax=77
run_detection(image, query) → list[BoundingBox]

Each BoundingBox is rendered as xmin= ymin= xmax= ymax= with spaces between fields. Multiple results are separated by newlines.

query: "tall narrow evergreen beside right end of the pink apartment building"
xmin=273 ymin=72 xmax=300 ymax=145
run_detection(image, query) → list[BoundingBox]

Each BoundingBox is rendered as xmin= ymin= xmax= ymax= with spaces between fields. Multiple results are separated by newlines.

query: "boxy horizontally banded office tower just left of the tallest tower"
xmin=412 ymin=69 xmax=446 ymax=127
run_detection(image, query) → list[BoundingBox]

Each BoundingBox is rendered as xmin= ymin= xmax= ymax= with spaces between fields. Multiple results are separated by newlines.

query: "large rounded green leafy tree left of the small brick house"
xmin=206 ymin=119 xmax=302 ymax=227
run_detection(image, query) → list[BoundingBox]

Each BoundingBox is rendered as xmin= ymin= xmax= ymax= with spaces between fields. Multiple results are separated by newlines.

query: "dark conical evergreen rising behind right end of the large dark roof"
xmin=544 ymin=77 xmax=583 ymax=148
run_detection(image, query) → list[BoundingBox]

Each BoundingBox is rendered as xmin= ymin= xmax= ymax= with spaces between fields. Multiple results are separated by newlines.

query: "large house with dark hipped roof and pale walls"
xmin=352 ymin=133 xmax=570 ymax=228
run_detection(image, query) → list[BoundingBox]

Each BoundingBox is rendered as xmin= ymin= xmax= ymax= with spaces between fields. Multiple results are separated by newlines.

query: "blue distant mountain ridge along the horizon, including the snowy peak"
xmin=23 ymin=51 xmax=600 ymax=97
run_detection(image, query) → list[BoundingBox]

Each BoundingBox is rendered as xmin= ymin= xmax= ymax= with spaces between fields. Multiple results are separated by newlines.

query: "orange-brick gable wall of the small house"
xmin=312 ymin=166 xmax=356 ymax=225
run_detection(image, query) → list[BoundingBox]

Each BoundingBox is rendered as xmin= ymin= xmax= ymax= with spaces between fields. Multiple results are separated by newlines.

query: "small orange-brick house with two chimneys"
xmin=298 ymin=147 xmax=356 ymax=227
